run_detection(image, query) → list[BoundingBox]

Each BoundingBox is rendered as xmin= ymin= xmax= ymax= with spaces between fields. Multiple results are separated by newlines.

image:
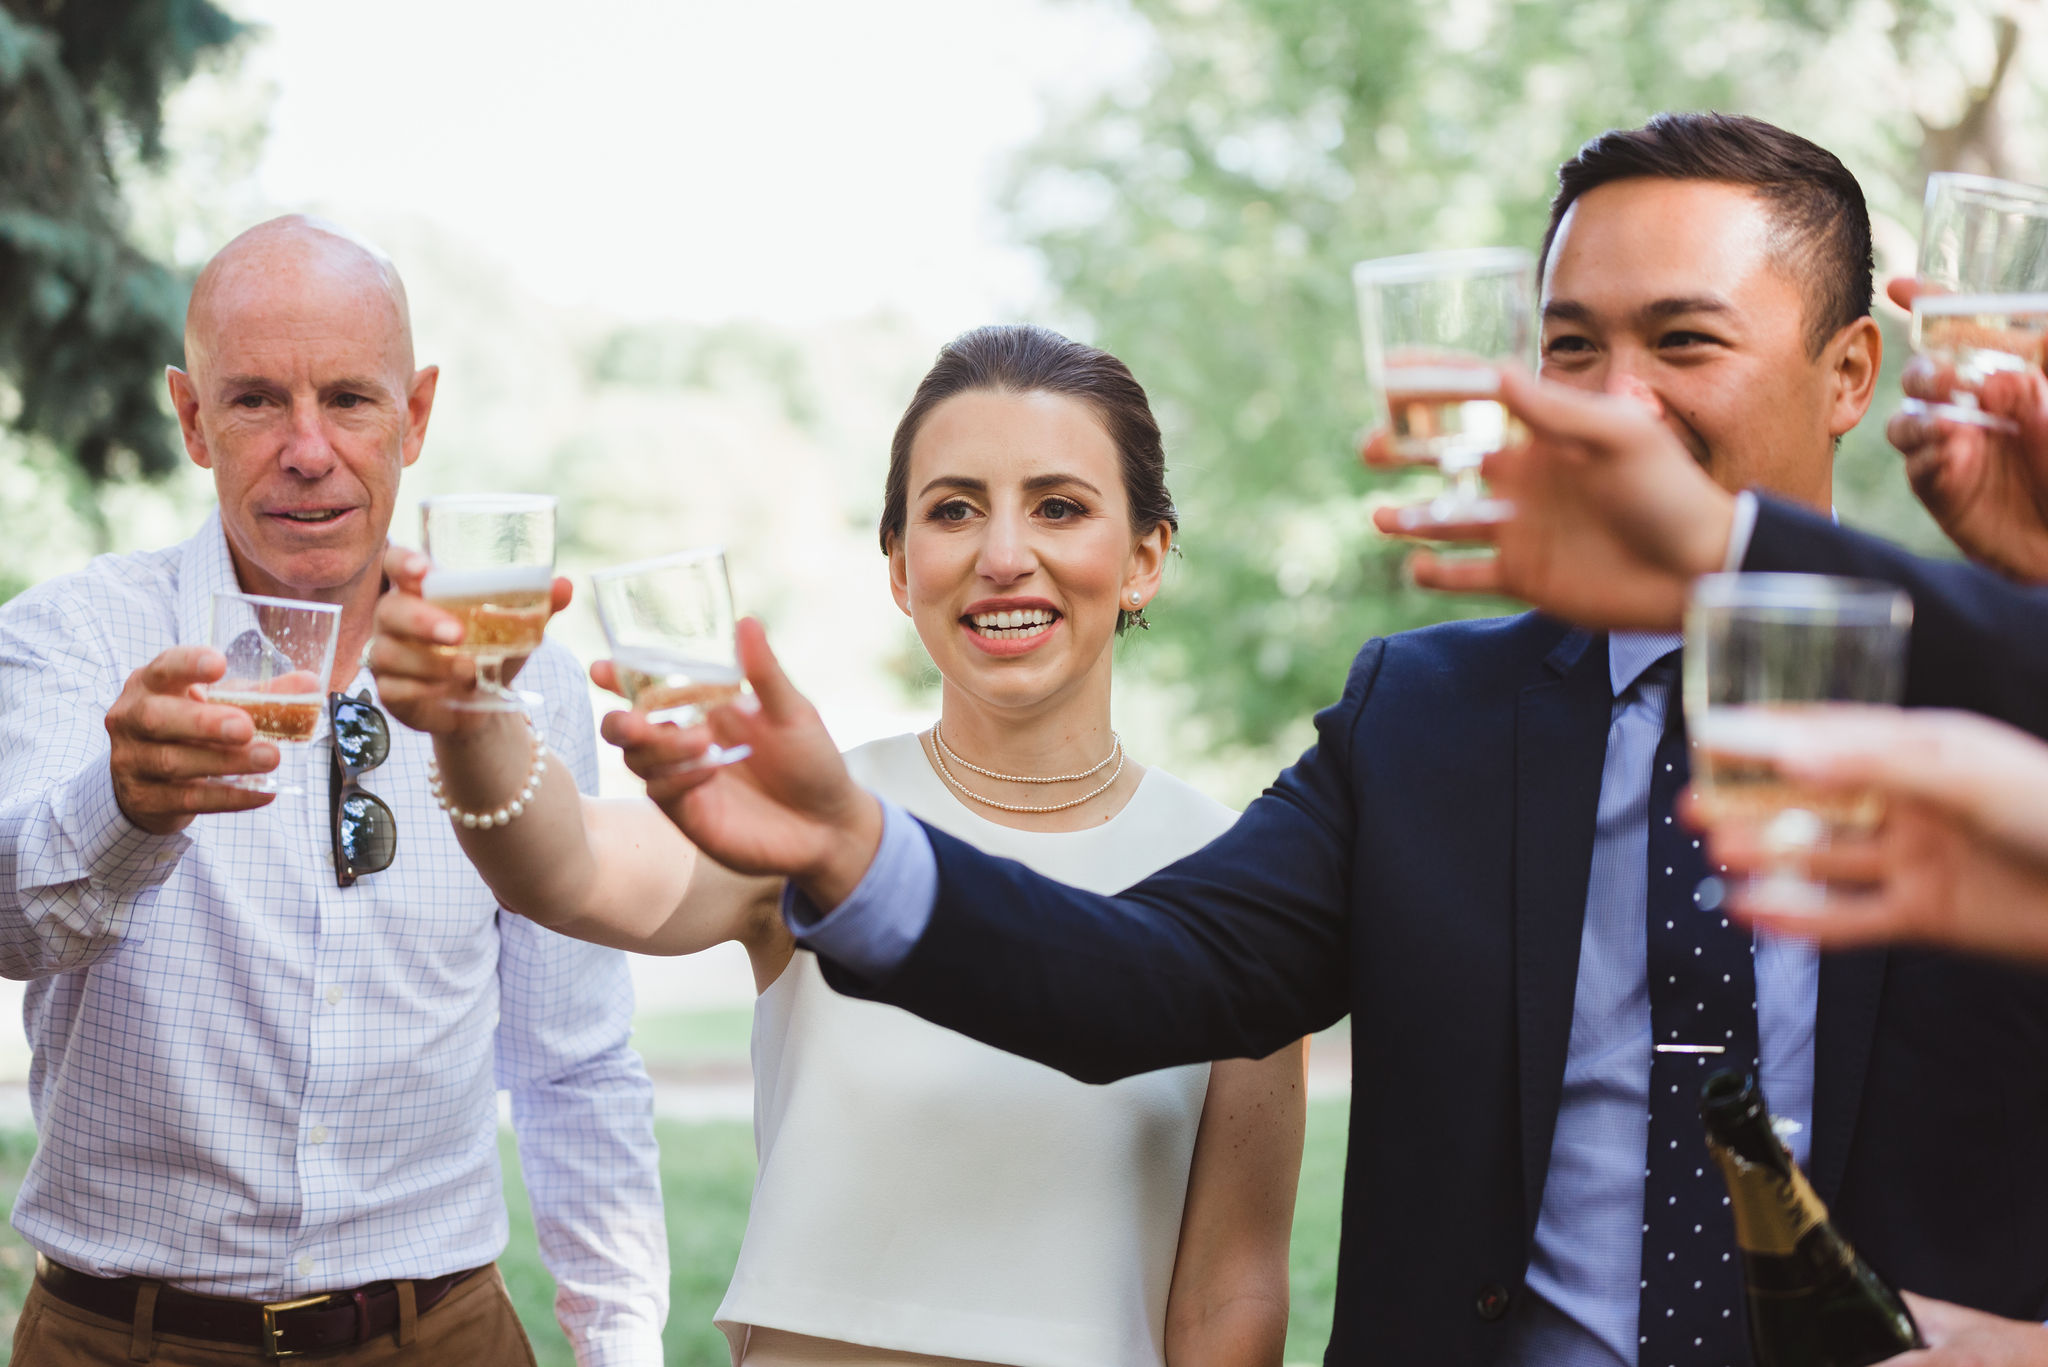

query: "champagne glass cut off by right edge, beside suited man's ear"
xmin=1903 ymin=172 xmax=2048 ymax=432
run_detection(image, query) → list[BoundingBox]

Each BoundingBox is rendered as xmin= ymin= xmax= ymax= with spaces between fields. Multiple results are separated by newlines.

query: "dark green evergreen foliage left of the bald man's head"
xmin=0 ymin=0 xmax=242 ymax=480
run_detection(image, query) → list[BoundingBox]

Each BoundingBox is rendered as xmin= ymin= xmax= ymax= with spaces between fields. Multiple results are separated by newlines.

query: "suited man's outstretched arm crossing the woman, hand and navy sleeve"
xmin=606 ymin=623 xmax=1382 ymax=1082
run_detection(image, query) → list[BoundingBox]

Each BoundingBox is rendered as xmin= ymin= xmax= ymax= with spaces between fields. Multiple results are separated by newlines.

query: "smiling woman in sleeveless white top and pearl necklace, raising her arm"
xmin=360 ymin=328 xmax=1305 ymax=1367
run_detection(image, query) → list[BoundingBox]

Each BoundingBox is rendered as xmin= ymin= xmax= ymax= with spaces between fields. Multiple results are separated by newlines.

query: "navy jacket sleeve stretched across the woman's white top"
xmin=793 ymin=641 xmax=1382 ymax=1082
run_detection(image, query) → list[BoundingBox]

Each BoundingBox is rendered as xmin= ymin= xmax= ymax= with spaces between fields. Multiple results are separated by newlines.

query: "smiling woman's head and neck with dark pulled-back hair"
xmin=881 ymin=326 xmax=1178 ymax=830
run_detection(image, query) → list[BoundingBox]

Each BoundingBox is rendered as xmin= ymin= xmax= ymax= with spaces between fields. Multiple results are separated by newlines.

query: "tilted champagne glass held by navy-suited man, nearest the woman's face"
xmin=590 ymin=547 xmax=752 ymax=764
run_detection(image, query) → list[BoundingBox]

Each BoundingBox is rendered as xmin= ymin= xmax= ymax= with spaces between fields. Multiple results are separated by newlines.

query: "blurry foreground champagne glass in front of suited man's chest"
xmin=1686 ymin=574 xmax=1913 ymax=908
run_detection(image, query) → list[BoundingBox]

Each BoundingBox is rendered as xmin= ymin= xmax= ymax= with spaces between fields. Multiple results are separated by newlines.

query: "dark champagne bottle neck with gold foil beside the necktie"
xmin=1700 ymin=1072 xmax=1925 ymax=1367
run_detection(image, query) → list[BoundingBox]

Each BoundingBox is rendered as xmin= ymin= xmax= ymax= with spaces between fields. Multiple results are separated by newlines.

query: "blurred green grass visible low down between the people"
xmin=0 ymin=1098 xmax=1346 ymax=1367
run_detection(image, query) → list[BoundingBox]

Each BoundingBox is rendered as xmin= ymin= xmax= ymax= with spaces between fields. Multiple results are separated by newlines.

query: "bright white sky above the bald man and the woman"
xmin=229 ymin=0 xmax=1145 ymax=334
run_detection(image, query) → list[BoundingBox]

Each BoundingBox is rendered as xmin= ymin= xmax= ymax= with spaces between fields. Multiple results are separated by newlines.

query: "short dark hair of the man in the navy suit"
xmin=1542 ymin=113 xmax=1874 ymax=355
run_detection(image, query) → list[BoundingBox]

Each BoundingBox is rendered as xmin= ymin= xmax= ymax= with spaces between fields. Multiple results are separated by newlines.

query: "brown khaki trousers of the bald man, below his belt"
xmin=12 ymin=1267 xmax=535 ymax=1367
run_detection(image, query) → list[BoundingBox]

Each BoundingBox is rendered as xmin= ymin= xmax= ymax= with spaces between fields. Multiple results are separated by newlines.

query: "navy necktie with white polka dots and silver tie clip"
xmin=1636 ymin=652 xmax=1757 ymax=1367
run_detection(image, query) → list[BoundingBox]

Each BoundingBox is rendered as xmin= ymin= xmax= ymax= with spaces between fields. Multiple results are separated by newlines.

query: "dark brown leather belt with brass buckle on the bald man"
xmin=35 ymin=1258 xmax=489 ymax=1357
